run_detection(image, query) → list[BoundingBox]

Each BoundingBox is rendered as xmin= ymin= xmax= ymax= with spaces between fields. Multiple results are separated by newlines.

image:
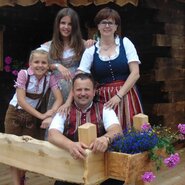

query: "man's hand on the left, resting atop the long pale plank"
xmin=69 ymin=142 xmax=88 ymax=160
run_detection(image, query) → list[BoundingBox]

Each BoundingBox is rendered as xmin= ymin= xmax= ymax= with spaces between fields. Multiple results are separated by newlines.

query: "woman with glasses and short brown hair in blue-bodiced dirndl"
xmin=78 ymin=8 xmax=143 ymax=129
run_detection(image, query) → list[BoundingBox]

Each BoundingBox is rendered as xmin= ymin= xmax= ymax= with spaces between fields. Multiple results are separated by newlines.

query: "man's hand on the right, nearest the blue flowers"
xmin=90 ymin=136 xmax=109 ymax=153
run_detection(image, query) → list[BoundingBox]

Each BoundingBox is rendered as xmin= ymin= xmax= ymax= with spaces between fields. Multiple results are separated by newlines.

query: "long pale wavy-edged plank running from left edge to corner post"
xmin=0 ymin=133 xmax=84 ymax=183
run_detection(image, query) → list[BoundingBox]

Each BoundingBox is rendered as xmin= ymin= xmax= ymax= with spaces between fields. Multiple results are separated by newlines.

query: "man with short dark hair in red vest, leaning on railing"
xmin=48 ymin=73 xmax=123 ymax=185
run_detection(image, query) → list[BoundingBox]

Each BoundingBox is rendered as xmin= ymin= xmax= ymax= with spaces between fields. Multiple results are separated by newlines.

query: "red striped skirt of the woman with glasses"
xmin=97 ymin=80 xmax=143 ymax=129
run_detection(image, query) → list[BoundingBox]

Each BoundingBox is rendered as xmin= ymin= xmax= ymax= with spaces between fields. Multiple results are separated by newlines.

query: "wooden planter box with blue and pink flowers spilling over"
xmin=107 ymin=123 xmax=185 ymax=185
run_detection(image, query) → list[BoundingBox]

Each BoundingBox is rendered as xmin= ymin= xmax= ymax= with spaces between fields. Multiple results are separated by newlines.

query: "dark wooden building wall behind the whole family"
xmin=0 ymin=0 xmax=185 ymax=131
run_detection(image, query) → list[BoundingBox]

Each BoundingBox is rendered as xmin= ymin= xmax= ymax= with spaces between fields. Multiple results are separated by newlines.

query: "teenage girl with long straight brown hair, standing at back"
xmin=41 ymin=8 xmax=94 ymax=124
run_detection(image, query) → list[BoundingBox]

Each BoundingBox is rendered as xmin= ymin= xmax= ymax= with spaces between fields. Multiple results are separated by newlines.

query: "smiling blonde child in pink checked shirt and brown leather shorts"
xmin=5 ymin=50 xmax=63 ymax=185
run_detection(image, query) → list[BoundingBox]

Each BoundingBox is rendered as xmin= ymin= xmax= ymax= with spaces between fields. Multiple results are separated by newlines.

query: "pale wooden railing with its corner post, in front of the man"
xmin=0 ymin=123 xmax=107 ymax=185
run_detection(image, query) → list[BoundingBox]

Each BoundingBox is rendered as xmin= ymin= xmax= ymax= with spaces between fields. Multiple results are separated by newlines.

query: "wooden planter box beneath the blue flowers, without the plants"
xmin=106 ymin=152 xmax=153 ymax=185
